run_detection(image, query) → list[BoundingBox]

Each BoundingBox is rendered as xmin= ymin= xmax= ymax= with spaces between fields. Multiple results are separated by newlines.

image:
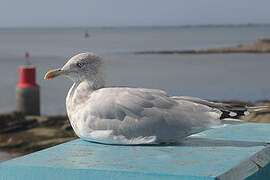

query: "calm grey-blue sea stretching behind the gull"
xmin=0 ymin=27 xmax=270 ymax=114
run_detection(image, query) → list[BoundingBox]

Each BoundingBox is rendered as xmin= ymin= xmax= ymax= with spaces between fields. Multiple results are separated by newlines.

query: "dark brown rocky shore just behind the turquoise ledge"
xmin=0 ymin=101 xmax=270 ymax=160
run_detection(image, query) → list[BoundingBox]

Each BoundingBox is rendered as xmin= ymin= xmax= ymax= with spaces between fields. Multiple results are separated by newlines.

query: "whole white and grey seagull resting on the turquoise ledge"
xmin=44 ymin=53 xmax=265 ymax=144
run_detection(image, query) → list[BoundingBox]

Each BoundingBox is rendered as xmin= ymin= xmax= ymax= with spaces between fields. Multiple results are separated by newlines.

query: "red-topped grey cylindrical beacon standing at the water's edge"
xmin=16 ymin=53 xmax=40 ymax=115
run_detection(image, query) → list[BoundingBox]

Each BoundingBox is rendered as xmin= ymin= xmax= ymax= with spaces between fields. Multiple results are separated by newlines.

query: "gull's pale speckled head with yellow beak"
xmin=44 ymin=53 xmax=102 ymax=82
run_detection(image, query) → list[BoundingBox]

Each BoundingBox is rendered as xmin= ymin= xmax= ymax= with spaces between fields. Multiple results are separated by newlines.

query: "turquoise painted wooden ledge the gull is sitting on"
xmin=0 ymin=123 xmax=270 ymax=180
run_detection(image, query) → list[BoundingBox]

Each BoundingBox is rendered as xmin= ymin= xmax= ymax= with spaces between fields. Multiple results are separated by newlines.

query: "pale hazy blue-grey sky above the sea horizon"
xmin=0 ymin=0 xmax=270 ymax=27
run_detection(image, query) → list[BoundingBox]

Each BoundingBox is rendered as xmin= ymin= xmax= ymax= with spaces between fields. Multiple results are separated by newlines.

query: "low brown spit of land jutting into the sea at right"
xmin=135 ymin=38 xmax=270 ymax=54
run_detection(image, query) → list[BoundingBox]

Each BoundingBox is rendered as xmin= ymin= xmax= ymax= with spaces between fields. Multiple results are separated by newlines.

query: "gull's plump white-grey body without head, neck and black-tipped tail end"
xmin=67 ymin=88 xmax=220 ymax=144
